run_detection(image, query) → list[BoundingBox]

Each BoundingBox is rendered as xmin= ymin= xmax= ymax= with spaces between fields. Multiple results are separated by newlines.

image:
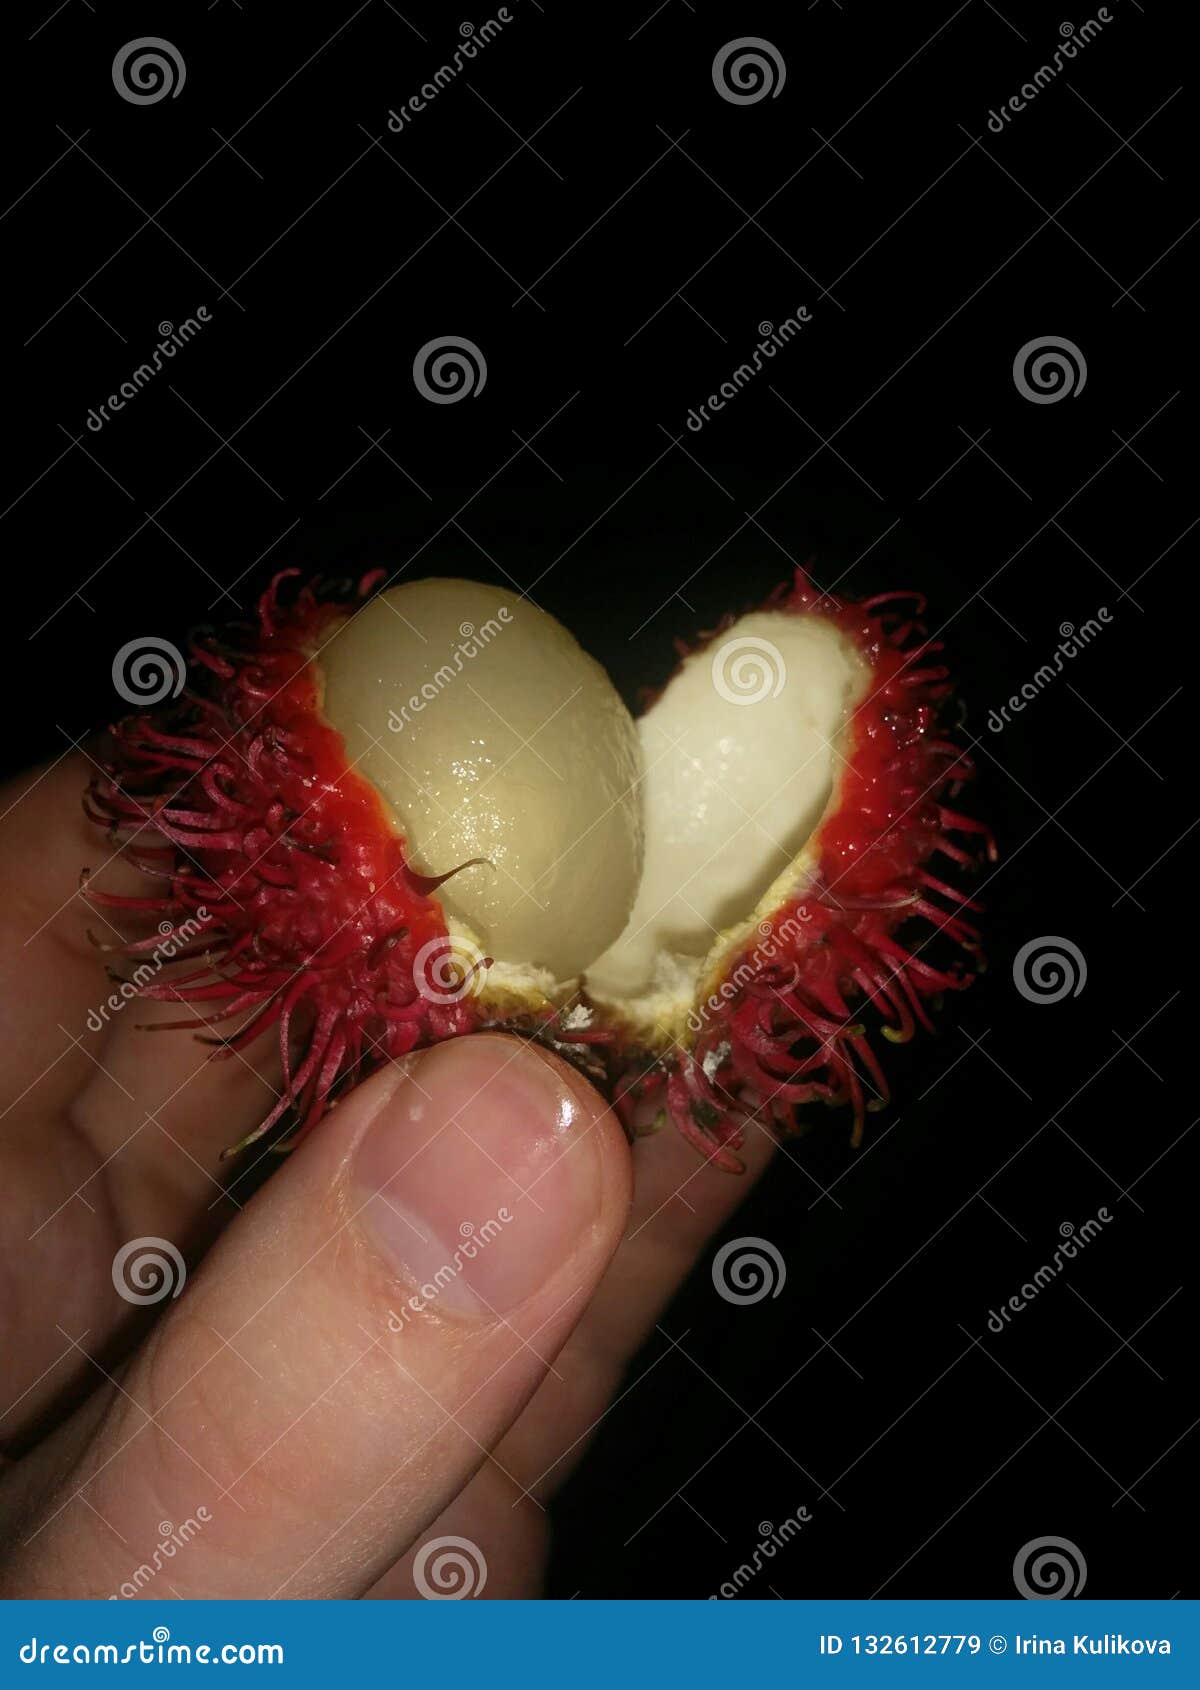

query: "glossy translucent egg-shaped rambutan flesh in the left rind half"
xmin=318 ymin=580 xmax=642 ymax=980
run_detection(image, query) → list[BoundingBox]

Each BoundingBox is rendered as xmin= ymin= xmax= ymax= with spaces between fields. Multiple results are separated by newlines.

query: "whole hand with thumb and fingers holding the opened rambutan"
xmin=0 ymin=754 xmax=771 ymax=1599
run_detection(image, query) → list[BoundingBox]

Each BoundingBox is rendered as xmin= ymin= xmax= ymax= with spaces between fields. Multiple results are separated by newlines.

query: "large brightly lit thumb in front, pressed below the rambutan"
xmin=3 ymin=1034 xmax=630 ymax=1597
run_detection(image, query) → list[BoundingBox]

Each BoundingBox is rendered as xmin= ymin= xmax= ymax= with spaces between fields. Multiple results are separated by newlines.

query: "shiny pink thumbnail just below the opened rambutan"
xmin=355 ymin=1034 xmax=603 ymax=1330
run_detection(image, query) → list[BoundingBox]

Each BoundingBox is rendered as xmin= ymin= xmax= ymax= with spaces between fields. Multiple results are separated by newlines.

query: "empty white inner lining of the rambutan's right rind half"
xmin=586 ymin=610 xmax=869 ymax=1026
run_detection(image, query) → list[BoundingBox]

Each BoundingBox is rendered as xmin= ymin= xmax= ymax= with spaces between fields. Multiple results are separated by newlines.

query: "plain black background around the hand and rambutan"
xmin=0 ymin=0 xmax=1197 ymax=1597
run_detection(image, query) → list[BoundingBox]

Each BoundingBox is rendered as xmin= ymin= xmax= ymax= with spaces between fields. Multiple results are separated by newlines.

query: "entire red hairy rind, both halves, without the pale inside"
xmin=85 ymin=570 xmax=994 ymax=1171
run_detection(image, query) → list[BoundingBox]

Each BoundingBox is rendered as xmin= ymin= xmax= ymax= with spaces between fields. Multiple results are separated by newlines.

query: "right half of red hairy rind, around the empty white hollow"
xmin=598 ymin=570 xmax=995 ymax=1173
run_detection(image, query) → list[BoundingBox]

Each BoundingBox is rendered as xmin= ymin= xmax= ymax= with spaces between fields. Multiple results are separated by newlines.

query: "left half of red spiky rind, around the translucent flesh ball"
xmin=85 ymin=570 xmax=482 ymax=1149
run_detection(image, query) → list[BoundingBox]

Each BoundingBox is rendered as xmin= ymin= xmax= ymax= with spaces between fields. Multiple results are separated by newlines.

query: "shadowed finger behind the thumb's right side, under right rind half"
xmin=370 ymin=1129 xmax=777 ymax=1600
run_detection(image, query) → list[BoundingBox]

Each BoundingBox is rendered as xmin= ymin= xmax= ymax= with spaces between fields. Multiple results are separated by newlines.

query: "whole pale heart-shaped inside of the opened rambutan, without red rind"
xmin=319 ymin=580 xmax=870 ymax=1014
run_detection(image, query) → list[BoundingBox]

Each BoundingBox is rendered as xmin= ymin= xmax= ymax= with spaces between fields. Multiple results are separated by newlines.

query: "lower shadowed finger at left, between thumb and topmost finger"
xmin=0 ymin=1004 xmax=287 ymax=1445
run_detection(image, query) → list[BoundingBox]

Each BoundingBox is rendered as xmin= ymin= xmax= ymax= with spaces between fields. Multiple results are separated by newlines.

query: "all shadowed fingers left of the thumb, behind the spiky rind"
xmin=0 ymin=752 xmax=279 ymax=1447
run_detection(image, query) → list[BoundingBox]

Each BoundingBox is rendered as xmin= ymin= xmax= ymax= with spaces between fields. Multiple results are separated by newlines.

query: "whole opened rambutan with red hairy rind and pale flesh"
xmin=86 ymin=571 xmax=992 ymax=1171
